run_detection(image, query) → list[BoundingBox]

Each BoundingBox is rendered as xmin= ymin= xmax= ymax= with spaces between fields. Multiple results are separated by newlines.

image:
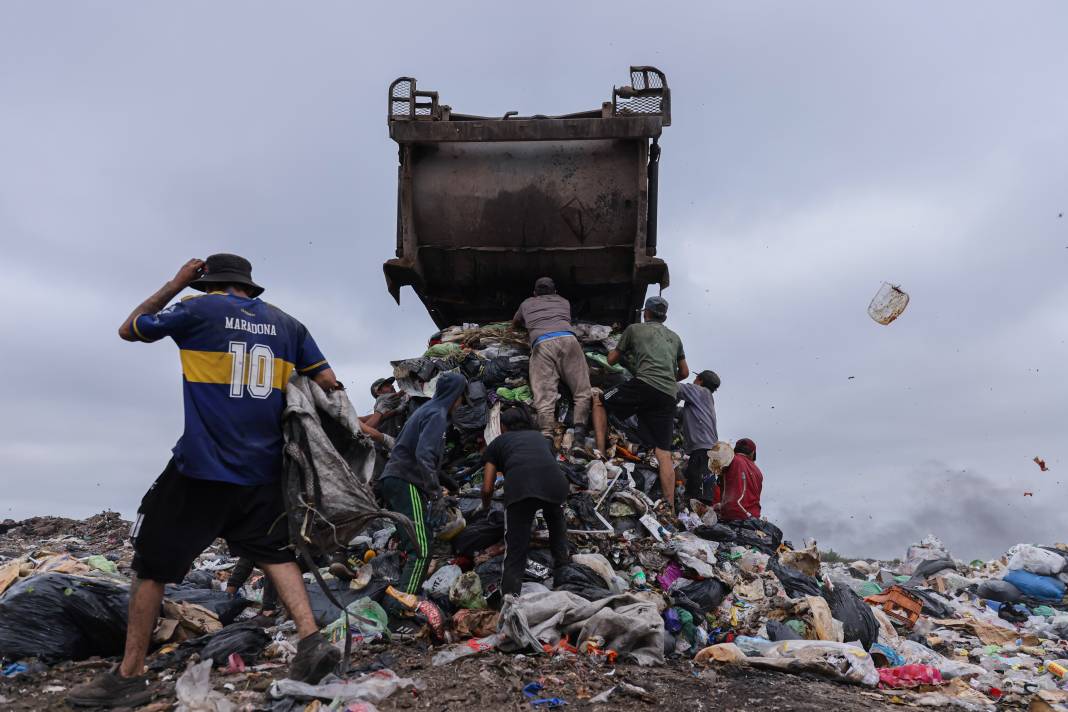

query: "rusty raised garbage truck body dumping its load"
xmin=383 ymin=66 xmax=671 ymax=328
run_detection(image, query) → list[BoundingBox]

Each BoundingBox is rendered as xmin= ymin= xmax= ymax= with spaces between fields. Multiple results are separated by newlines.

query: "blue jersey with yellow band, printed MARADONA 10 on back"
xmin=132 ymin=291 xmax=329 ymax=485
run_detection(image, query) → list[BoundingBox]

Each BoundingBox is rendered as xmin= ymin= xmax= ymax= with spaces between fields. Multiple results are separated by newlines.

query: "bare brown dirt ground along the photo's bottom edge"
xmin=0 ymin=645 xmax=900 ymax=712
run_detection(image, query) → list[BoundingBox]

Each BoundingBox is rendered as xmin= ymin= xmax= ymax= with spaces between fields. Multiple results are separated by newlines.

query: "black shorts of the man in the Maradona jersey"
xmin=130 ymin=460 xmax=296 ymax=583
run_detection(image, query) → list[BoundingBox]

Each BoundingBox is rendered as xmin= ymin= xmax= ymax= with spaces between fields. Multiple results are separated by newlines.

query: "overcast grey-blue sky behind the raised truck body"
xmin=0 ymin=0 xmax=1068 ymax=558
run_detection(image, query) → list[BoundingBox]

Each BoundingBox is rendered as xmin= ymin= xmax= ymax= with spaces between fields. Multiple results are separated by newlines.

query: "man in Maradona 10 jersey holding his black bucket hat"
xmin=67 ymin=254 xmax=342 ymax=707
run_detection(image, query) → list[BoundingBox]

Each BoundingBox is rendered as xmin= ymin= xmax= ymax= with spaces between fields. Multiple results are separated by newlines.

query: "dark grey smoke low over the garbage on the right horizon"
xmin=767 ymin=462 xmax=1066 ymax=560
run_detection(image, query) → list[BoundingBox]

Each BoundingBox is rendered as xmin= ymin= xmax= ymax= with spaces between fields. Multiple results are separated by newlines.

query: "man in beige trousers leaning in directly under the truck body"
xmin=512 ymin=276 xmax=591 ymax=442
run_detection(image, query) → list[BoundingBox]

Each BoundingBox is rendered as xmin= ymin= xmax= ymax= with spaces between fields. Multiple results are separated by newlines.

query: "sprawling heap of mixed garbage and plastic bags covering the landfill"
xmin=0 ymin=325 xmax=1068 ymax=711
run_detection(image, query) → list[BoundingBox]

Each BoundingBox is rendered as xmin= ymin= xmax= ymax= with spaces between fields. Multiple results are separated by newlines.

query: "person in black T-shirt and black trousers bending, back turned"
xmin=482 ymin=408 xmax=571 ymax=596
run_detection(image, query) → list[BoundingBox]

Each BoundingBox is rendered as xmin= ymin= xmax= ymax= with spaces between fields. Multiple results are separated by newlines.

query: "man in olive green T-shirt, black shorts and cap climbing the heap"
xmin=594 ymin=297 xmax=690 ymax=509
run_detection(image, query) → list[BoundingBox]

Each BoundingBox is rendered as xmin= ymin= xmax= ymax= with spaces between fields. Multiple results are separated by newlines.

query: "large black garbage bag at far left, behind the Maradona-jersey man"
xmin=0 ymin=573 xmax=129 ymax=662
